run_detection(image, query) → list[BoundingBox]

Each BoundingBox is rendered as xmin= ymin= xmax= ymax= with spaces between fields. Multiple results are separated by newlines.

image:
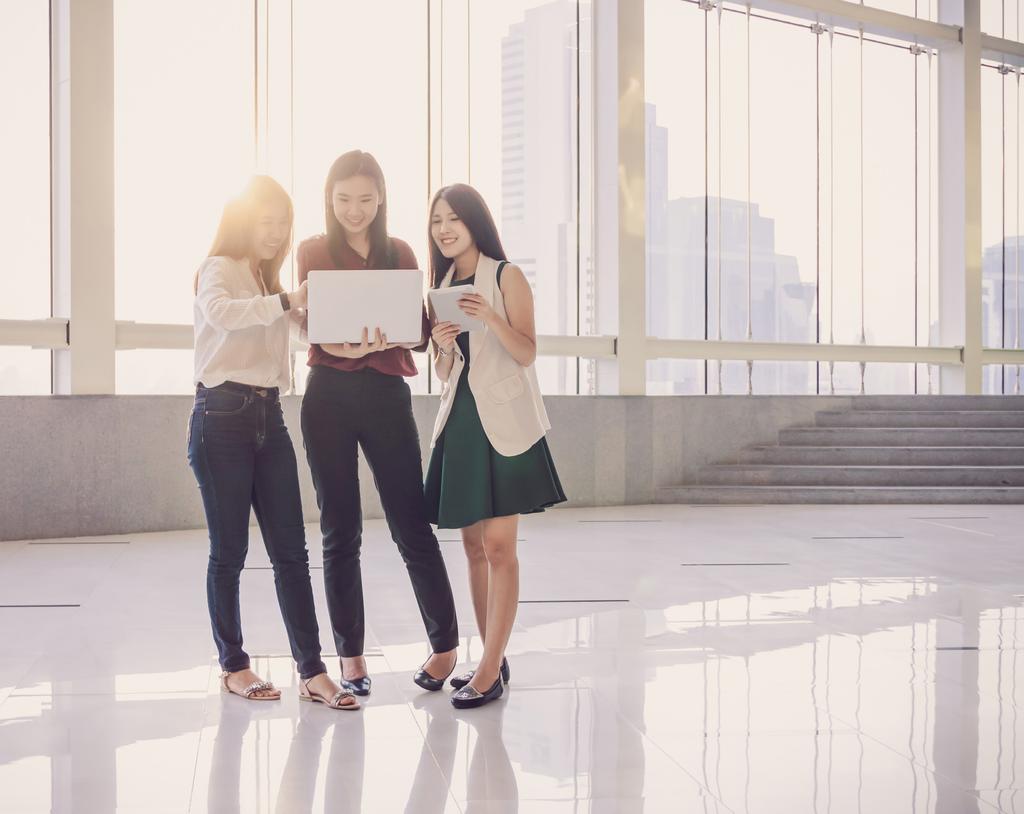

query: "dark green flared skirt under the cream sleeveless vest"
xmin=424 ymin=373 xmax=565 ymax=528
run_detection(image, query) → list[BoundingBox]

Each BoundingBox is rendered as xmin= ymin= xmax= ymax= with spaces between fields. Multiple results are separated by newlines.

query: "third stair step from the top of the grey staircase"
xmin=778 ymin=427 xmax=1024 ymax=446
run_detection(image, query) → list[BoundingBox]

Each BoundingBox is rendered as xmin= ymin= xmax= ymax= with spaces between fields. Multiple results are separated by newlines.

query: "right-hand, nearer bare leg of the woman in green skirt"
xmin=470 ymin=515 xmax=519 ymax=692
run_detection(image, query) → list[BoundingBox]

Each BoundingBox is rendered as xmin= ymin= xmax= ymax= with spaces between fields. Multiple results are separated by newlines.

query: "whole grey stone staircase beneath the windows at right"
xmin=657 ymin=395 xmax=1024 ymax=504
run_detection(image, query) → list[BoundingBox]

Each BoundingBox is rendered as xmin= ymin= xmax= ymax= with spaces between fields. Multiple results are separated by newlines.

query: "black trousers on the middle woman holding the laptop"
xmin=302 ymin=367 xmax=459 ymax=656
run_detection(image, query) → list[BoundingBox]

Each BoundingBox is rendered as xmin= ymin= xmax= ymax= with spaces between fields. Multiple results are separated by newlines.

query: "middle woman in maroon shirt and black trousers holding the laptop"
xmin=298 ymin=151 xmax=459 ymax=695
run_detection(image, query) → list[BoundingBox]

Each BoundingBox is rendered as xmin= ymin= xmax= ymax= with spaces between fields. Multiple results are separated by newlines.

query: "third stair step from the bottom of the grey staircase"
xmin=735 ymin=444 xmax=1024 ymax=466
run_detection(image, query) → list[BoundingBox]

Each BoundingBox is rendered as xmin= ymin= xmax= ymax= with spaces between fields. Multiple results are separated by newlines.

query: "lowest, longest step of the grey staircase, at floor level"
xmin=655 ymin=486 xmax=1024 ymax=505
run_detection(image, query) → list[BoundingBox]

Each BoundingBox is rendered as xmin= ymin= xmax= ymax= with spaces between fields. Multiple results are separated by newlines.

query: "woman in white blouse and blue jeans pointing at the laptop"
xmin=187 ymin=176 xmax=359 ymax=710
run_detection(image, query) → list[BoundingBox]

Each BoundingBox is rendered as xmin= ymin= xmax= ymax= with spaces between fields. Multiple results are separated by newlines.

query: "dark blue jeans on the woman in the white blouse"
xmin=188 ymin=382 xmax=326 ymax=679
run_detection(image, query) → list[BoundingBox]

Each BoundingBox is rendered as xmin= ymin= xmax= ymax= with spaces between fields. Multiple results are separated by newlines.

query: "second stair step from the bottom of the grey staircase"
xmin=696 ymin=465 xmax=1024 ymax=486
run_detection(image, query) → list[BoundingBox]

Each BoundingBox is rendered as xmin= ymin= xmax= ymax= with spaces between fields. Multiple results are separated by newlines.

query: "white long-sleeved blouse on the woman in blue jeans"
xmin=193 ymin=257 xmax=302 ymax=392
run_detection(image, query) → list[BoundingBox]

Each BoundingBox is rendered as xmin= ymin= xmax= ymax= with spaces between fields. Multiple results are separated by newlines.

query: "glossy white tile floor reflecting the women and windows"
xmin=0 ymin=506 xmax=1024 ymax=814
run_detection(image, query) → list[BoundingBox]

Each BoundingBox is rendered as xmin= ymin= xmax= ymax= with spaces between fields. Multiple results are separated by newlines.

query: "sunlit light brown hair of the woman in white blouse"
xmin=193 ymin=175 xmax=295 ymax=294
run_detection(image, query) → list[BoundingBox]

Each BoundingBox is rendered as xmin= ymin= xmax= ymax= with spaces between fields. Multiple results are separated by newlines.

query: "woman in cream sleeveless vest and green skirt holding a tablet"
xmin=425 ymin=184 xmax=565 ymax=709
